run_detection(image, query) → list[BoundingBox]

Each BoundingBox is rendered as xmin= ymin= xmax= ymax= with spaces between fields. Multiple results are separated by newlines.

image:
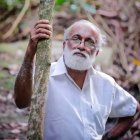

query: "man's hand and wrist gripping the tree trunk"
xmin=29 ymin=19 xmax=52 ymax=54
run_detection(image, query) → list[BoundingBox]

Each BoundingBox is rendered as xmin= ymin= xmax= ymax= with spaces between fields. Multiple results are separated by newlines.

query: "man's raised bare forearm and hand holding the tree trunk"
xmin=14 ymin=20 xmax=52 ymax=108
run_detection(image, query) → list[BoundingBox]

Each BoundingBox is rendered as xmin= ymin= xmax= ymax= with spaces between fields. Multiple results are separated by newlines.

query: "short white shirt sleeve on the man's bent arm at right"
xmin=109 ymin=82 xmax=137 ymax=117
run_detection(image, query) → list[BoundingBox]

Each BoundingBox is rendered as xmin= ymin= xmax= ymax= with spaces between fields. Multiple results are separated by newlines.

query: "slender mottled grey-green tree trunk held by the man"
xmin=27 ymin=0 xmax=54 ymax=140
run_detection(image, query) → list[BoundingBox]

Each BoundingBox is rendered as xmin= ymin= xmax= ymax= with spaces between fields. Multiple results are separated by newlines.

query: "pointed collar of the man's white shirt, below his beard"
xmin=51 ymin=56 xmax=96 ymax=76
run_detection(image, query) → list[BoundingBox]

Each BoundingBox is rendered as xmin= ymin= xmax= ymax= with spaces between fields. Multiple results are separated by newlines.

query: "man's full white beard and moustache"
xmin=63 ymin=46 xmax=95 ymax=71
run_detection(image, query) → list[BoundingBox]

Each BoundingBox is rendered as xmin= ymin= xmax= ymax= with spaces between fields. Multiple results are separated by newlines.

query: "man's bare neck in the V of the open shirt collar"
xmin=66 ymin=66 xmax=87 ymax=89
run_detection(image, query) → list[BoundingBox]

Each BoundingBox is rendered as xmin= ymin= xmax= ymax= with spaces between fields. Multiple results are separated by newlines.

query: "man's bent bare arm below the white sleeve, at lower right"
xmin=102 ymin=104 xmax=140 ymax=140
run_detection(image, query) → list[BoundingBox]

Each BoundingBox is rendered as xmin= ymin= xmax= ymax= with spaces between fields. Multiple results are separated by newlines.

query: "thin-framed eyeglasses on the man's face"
xmin=66 ymin=35 xmax=96 ymax=49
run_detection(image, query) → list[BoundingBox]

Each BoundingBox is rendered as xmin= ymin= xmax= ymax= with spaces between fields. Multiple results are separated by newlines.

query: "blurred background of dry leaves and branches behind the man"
xmin=0 ymin=0 xmax=140 ymax=140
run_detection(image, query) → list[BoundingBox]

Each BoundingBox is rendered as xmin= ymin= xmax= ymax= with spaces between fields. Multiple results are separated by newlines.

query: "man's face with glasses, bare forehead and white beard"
xmin=64 ymin=23 xmax=98 ymax=71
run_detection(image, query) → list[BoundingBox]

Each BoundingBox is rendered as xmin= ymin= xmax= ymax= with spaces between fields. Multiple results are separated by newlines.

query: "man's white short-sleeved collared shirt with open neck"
xmin=44 ymin=57 xmax=137 ymax=140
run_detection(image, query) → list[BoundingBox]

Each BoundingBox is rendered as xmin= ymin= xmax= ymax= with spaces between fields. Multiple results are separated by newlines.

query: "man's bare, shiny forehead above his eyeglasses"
xmin=68 ymin=22 xmax=98 ymax=39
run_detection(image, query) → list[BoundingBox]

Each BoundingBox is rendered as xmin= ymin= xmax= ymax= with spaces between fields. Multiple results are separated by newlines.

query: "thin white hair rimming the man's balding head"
xmin=64 ymin=19 xmax=106 ymax=49
